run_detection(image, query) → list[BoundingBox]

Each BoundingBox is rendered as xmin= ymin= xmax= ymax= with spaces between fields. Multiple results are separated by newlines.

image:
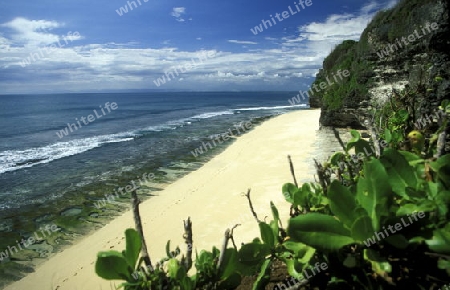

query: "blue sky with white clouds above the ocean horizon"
xmin=0 ymin=0 xmax=397 ymax=94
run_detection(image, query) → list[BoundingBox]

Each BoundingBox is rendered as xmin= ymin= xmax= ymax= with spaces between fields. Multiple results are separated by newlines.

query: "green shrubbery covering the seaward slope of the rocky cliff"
xmin=312 ymin=0 xmax=436 ymax=111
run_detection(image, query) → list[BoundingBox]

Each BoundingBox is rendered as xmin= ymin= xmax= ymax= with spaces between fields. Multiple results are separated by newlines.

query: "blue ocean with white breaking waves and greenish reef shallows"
xmin=0 ymin=92 xmax=308 ymax=285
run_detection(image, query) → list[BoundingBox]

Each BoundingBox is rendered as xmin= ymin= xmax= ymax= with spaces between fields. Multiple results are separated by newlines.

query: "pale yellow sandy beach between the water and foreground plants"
xmin=5 ymin=110 xmax=320 ymax=290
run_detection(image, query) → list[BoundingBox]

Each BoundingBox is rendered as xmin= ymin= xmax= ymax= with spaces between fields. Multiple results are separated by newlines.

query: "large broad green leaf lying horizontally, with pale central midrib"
xmin=288 ymin=213 xmax=355 ymax=250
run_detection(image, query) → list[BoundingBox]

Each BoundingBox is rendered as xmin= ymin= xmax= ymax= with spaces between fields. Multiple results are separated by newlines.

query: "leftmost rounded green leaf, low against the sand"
xmin=95 ymin=251 xmax=133 ymax=282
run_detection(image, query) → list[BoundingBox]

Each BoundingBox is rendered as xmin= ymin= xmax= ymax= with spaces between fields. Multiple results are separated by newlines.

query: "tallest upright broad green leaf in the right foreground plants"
xmin=356 ymin=159 xmax=392 ymax=231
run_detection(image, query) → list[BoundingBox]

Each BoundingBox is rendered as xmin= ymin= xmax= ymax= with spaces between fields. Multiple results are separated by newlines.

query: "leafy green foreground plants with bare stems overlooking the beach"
xmin=96 ymin=98 xmax=450 ymax=290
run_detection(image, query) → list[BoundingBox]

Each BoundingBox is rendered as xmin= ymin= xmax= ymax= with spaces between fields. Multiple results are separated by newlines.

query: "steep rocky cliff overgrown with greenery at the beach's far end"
xmin=310 ymin=0 xmax=450 ymax=128
